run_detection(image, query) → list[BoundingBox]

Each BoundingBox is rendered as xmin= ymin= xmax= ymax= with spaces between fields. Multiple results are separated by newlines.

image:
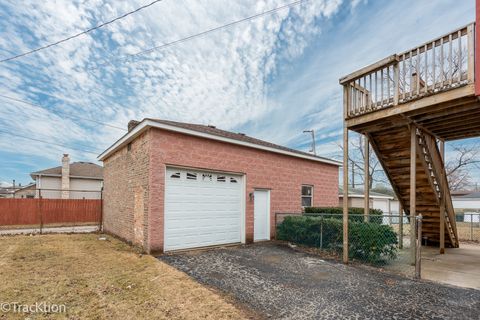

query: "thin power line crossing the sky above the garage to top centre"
xmin=89 ymin=0 xmax=309 ymax=70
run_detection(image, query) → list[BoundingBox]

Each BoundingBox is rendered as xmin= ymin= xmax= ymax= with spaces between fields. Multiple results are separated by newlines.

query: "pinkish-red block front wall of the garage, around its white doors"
xmin=147 ymin=129 xmax=338 ymax=252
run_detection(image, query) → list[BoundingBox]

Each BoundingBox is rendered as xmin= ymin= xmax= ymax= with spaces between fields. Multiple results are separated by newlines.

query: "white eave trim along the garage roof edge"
xmin=97 ymin=119 xmax=342 ymax=166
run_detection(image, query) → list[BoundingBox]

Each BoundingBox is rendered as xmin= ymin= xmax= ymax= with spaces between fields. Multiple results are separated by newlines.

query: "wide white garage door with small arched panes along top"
xmin=164 ymin=167 xmax=243 ymax=251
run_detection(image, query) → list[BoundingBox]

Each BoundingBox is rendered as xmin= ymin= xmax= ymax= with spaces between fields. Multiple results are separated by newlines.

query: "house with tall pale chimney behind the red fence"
xmin=30 ymin=154 xmax=103 ymax=199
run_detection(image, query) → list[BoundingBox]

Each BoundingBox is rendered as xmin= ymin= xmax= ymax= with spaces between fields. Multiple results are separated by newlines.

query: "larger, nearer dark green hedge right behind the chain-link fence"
xmin=277 ymin=216 xmax=398 ymax=265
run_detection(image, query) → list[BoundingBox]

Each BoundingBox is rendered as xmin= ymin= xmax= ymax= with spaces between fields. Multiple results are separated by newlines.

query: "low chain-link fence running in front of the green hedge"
xmin=276 ymin=213 xmax=421 ymax=277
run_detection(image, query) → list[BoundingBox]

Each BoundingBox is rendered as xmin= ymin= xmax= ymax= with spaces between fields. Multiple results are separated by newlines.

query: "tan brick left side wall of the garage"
xmin=103 ymin=131 xmax=150 ymax=247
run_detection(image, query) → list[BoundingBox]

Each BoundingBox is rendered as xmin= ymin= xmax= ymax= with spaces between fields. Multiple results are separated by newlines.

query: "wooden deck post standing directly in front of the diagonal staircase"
xmin=410 ymin=125 xmax=417 ymax=264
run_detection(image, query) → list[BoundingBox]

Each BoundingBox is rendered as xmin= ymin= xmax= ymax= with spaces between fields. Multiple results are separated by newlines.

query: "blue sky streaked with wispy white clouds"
xmin=0 ymin=0 xmax=474 ymax=184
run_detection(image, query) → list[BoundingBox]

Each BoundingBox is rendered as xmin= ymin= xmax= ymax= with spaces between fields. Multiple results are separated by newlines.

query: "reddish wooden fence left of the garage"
xmin=0 ymin=199 xmax=102 ymax=226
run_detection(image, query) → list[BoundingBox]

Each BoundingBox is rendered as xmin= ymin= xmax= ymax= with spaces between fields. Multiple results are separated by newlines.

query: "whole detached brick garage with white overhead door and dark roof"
xmin=99 ymin=119 xmax=341 ymax=253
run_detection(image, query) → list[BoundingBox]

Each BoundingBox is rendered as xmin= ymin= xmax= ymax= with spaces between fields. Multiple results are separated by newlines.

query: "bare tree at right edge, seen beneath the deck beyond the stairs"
xmin=445 ymin=144 xmax=480 ymax=190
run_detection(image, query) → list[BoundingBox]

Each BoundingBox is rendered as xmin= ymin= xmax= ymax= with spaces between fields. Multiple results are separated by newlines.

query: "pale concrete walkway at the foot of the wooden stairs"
xmin=422 ymin=243 xmax=480 ymax=290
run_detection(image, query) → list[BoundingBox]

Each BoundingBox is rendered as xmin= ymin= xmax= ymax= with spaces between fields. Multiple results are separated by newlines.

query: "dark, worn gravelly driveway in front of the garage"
xmin=159 ymin=243 xmax=480 ymax=319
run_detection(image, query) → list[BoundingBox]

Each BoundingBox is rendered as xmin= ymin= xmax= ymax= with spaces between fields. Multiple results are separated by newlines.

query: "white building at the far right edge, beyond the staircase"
xmin=452 ymin=191 xmax=480 ymax=222
